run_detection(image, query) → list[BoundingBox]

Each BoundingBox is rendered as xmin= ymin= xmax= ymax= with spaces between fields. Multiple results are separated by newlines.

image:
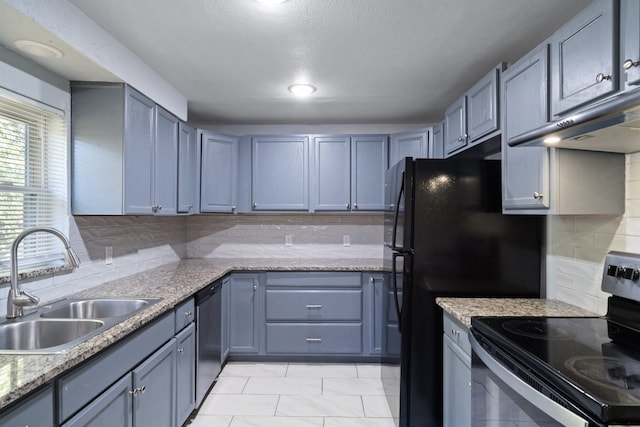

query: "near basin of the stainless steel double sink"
xmin=0 ymin=319 xmax=105 ymax=352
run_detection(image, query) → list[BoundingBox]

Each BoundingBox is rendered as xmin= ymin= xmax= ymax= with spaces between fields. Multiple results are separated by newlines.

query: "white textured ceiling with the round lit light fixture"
xmin=0 ymin=0 xmax=590 ymax=125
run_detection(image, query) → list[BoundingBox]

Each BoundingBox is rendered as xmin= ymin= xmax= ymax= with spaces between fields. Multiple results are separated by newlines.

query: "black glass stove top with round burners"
xmin=472 ymin=317 xmax=640 ymax=422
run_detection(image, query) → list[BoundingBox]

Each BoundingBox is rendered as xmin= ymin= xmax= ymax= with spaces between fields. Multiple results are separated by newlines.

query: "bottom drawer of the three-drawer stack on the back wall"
xmin=266 ymin=323 xmax=362 ymax=354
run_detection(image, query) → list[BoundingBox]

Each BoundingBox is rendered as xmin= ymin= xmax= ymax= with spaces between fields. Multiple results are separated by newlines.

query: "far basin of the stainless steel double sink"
xmin=40 ymin=299 xmax=152 ymax=319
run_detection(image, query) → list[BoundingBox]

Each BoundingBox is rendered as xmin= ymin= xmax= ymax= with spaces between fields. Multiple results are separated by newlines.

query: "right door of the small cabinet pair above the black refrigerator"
xmin=466 ymin=68 xmax=500 ymax=141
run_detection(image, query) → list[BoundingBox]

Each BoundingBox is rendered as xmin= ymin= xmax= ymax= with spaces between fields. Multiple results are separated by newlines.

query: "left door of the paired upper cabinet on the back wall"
xmin=313 ymin=136 xmax=351 ymax=211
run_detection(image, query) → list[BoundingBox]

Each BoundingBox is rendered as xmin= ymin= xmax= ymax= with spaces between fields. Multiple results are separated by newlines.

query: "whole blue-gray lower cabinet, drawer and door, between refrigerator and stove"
xmin=442 ymin=313 xmax=471 ymax=427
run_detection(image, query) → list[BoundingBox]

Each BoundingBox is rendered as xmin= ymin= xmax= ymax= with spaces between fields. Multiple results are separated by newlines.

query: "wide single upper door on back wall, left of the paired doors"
xmin=251 ymin=136 xmax=309 ymax=211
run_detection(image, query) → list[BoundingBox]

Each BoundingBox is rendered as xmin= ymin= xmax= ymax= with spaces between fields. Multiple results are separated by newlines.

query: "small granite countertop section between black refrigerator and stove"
xmin=436 ymin=298 xmax=598 ymax=328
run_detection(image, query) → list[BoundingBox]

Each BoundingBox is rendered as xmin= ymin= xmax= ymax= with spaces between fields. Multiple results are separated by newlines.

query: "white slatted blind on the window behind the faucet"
xmin=0 ymin=92 xmax=68 ymax=276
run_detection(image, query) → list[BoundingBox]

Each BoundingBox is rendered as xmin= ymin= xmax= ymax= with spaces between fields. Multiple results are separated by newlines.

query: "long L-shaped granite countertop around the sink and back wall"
xmin=0 ymin=258 xmax=382 ymax=410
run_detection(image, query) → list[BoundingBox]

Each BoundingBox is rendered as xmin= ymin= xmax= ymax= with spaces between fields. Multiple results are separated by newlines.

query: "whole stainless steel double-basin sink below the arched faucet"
xmin=0 ymin=298 xmax=160 ymax=354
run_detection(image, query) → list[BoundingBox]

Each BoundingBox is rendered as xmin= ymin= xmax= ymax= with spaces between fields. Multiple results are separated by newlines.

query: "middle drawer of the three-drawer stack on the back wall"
xmin=266 ymin=289 xmax=362 ymax=321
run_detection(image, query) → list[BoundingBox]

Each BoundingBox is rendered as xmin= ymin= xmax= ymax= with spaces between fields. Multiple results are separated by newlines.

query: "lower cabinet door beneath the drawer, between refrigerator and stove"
xmin=442 ymin=335 xmax=471 ymax=427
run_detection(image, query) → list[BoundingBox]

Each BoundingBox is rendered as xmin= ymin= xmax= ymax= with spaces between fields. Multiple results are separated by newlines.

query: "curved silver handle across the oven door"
xmin=469 ymin=334 xmax=589 ymax=427
